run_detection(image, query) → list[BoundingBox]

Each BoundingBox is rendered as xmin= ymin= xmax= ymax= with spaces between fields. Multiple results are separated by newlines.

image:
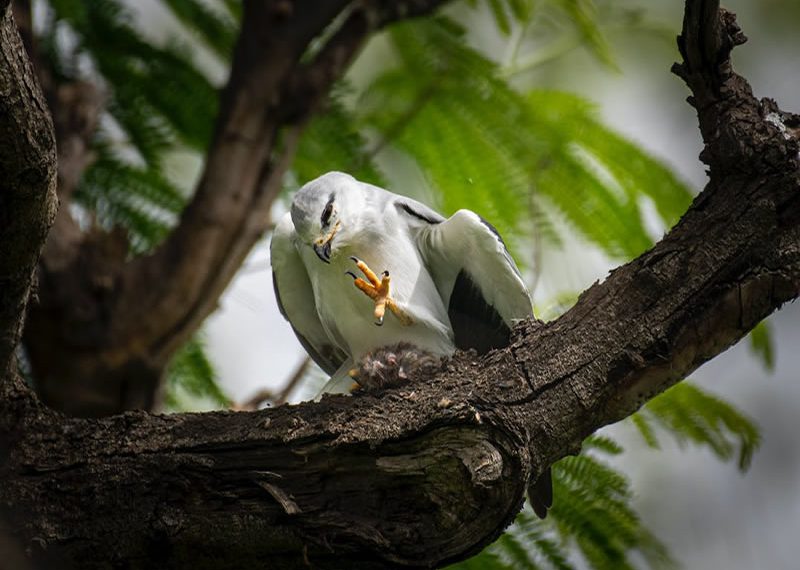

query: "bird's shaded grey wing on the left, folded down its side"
xmin=270 ymin=213 xmax=347 ymax=374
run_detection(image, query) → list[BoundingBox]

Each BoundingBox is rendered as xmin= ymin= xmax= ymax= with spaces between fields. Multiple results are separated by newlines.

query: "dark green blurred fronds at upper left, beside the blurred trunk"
xmin=45 ymin=0 xmax=217 ymax=253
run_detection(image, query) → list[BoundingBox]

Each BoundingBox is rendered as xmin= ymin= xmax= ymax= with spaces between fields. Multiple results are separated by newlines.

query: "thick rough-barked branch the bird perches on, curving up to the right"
xmin=0 ymin=0 xmax=800 ymax=568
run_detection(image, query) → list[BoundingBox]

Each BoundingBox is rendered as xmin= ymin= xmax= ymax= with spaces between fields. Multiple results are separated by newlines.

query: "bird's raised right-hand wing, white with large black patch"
xmin=409 ymin=204 xmax=533 ymax=354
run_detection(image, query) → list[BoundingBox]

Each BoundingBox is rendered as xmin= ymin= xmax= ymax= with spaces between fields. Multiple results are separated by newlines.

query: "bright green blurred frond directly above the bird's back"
xmin=362 ymin=18 xmax=528 ymax=245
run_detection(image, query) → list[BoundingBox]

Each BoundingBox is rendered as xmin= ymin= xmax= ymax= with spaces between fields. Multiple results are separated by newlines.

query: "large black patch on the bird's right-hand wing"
xmin=447 ymin=269 xmax=511 ymax=354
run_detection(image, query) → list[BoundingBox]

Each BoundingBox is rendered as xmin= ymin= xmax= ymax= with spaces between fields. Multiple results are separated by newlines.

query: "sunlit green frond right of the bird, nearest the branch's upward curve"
xmin=528 ymin=90 xmax=691 ymax=259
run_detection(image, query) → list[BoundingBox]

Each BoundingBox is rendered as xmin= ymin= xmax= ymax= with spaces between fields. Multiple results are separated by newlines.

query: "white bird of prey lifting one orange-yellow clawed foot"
xmin=270 ymin=172 xmax=552 ymax=516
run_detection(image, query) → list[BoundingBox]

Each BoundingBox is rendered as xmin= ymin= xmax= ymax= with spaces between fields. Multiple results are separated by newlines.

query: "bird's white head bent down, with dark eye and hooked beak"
xmin=292 ymin=172 xmax=362 ymax=263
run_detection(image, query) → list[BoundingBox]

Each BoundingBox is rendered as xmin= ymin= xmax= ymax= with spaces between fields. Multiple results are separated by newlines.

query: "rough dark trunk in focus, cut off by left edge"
xmin=0 ymin=2 xmax=58 ymax=377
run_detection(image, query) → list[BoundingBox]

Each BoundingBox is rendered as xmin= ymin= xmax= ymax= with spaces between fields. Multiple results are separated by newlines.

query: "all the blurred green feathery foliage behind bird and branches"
xmin=34 ymin=0 xmax=773 ymax=570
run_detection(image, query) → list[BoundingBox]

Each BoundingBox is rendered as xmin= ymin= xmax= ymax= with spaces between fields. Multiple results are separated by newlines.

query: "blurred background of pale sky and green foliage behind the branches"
xmin=17 ymin=0 xmax=800 ymax=570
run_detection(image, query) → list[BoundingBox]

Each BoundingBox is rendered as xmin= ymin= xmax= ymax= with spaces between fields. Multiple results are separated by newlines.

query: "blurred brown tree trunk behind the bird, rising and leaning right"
xmin=20 ymin=0 xmax=444 ymax=416
